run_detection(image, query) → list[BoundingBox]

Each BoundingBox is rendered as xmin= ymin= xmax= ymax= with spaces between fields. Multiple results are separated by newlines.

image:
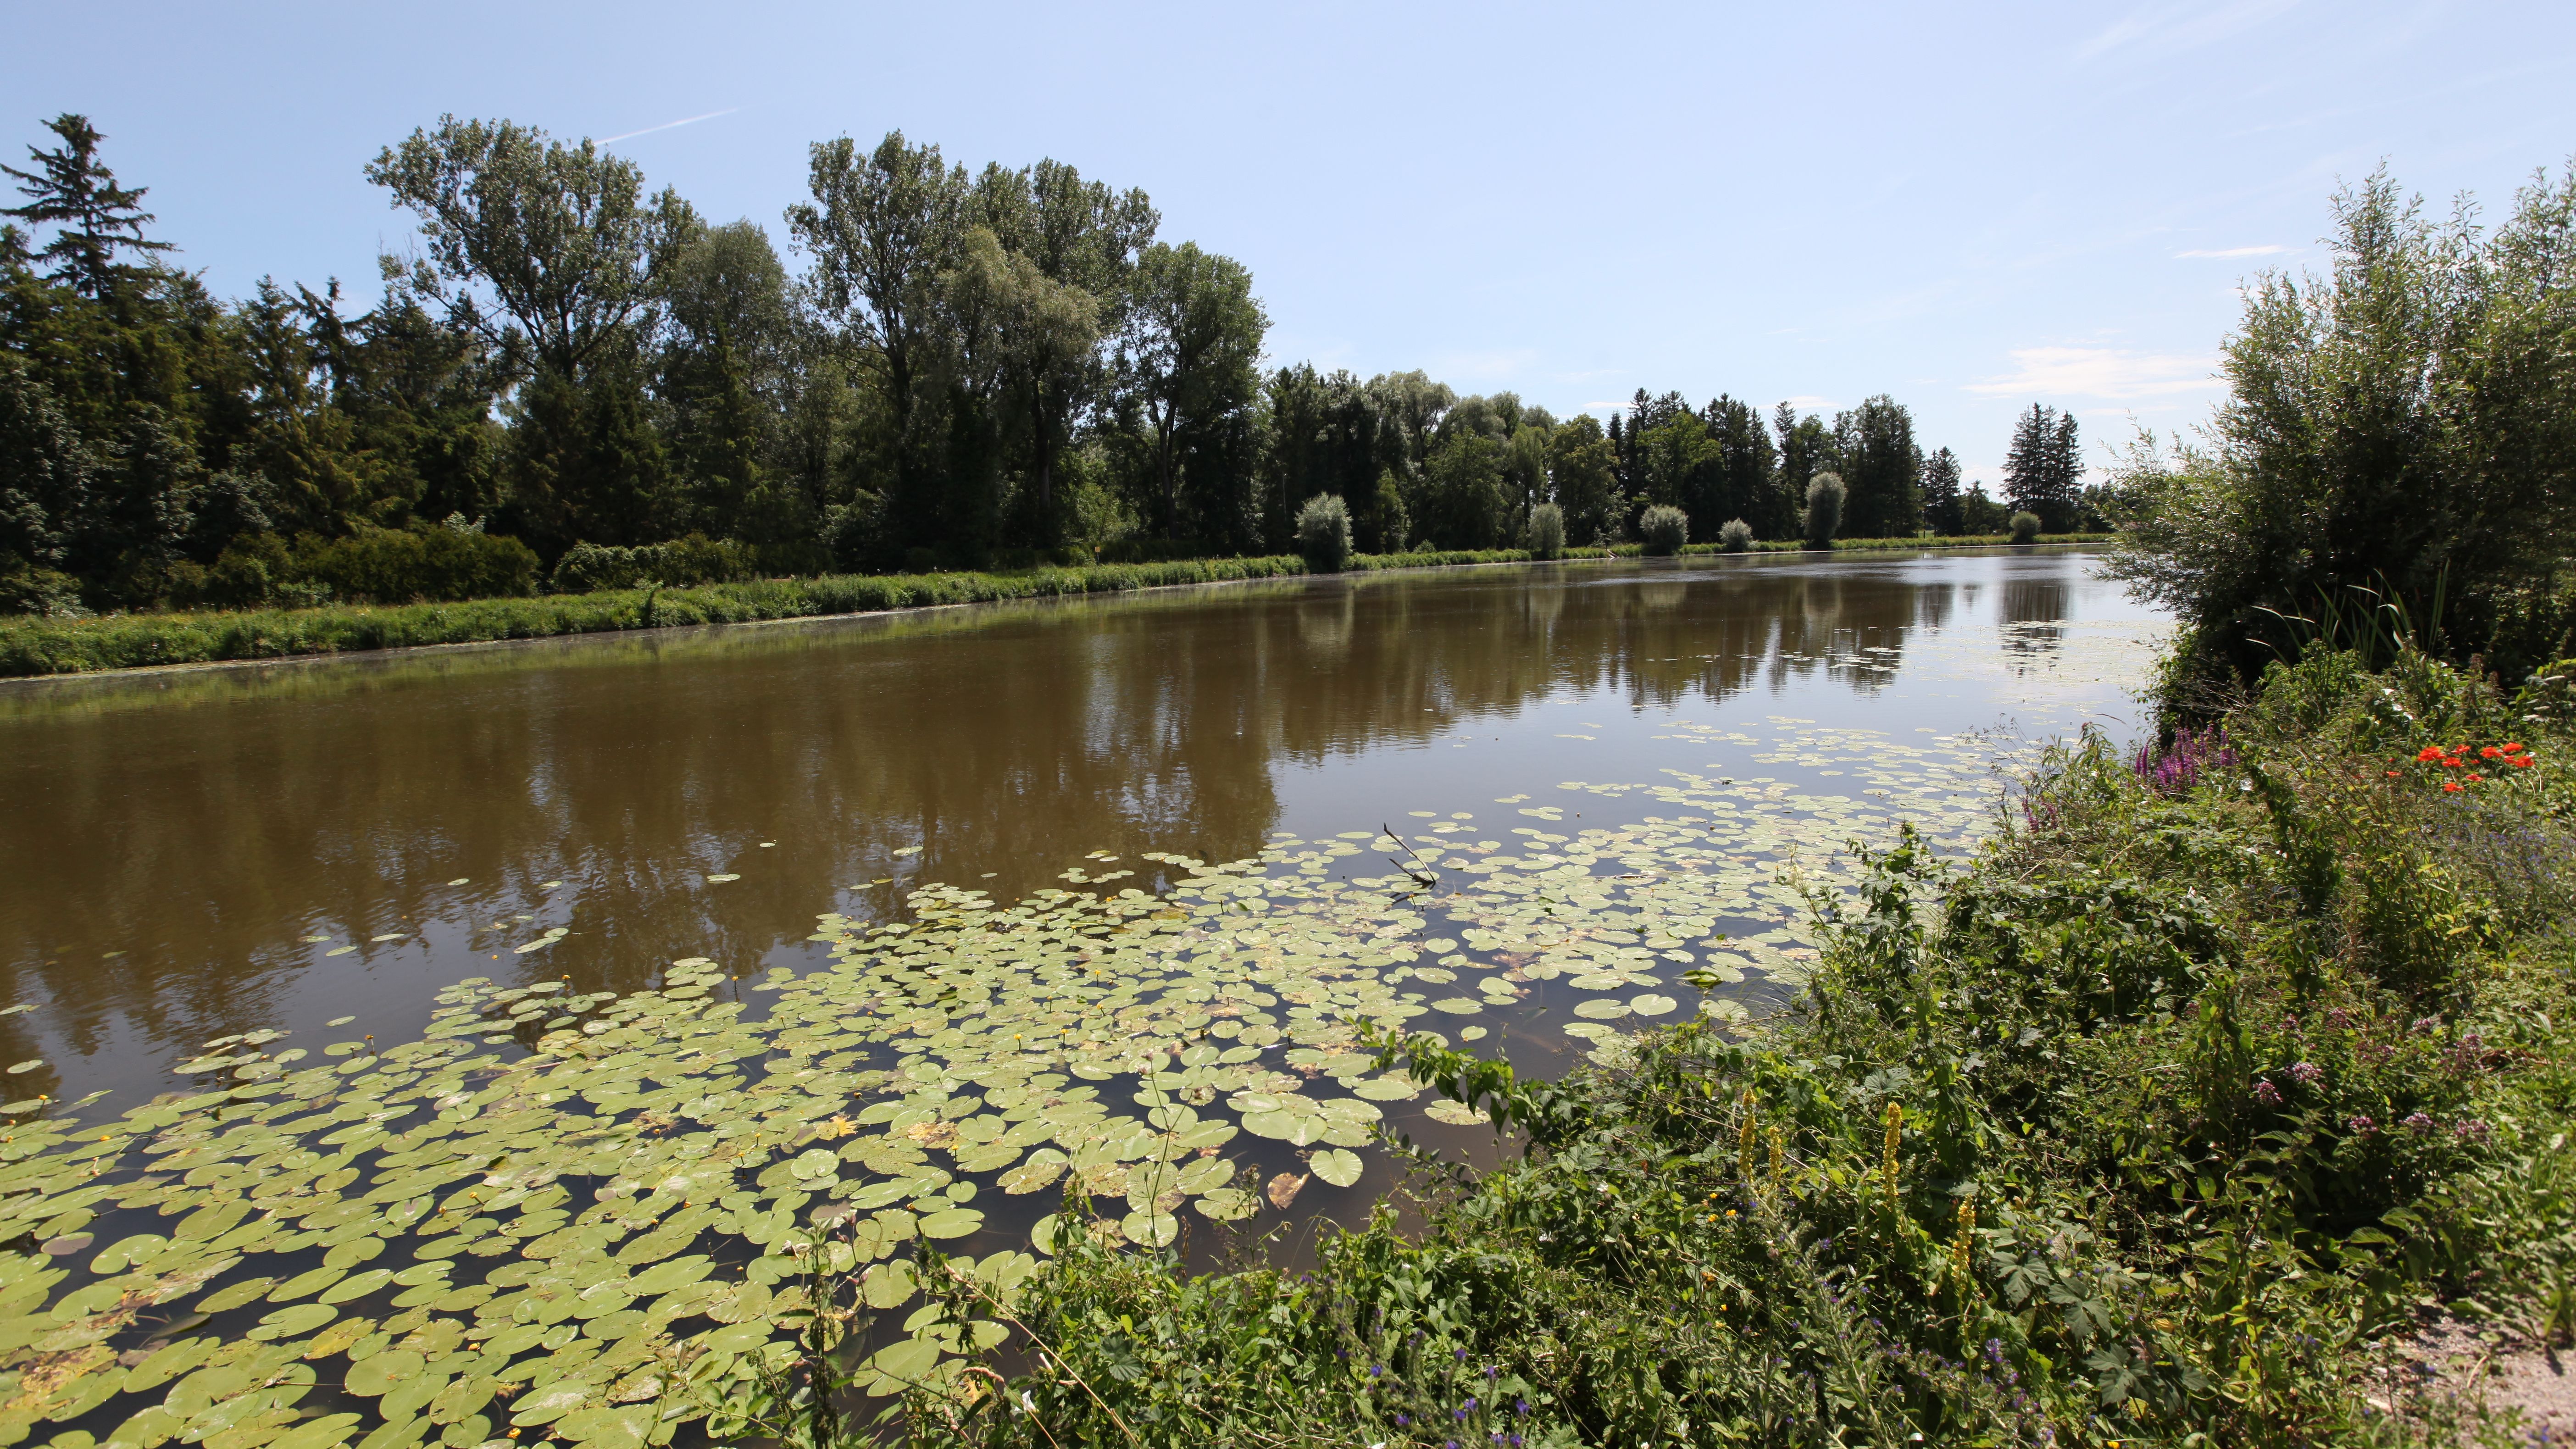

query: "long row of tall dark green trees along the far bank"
xmin=0 ymin=116 xmax=2099 ymax=611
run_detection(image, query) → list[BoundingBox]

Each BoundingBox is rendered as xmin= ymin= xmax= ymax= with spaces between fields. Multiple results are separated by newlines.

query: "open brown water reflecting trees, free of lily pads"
xmin=0 ymin=549 xmax=2161 ymax=1104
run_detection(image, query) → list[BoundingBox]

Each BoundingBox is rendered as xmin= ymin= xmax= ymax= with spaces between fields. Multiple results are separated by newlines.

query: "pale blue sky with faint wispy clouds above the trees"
xmin=0 ymin=0 xmax=2576 ymax=477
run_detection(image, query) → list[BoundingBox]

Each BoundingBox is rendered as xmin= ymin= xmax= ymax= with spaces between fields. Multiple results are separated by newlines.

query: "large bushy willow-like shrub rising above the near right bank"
xmin=2112 ymin=160 xmax=2576 ymax=681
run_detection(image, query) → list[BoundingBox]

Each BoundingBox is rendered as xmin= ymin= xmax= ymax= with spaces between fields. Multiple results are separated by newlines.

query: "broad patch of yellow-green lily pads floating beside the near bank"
xmin=0 ymin=686 xmax=2143 ymax=1449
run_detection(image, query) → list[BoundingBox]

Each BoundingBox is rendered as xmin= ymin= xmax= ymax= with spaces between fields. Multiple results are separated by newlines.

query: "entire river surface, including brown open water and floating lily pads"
xmin=0 ymin=549 xmax=2166 ymax=1449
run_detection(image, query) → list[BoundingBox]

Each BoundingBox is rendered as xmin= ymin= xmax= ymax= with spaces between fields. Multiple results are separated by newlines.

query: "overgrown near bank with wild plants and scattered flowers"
xmin=783 ymin=644 xmax=2576 ymax=1449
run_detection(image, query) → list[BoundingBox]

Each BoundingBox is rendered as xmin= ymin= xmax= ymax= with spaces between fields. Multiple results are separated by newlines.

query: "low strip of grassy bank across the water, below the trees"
xmin=0 ymin=534 xmax=2102 ymax=678
